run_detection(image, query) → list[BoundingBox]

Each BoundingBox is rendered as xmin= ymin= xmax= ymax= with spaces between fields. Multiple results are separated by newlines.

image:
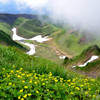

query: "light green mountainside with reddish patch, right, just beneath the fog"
xmin=53 ymin=27 xmax=100 ymax=57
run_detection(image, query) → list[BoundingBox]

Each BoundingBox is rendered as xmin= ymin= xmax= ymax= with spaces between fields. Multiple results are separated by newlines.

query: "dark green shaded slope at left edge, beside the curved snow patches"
xmin=0 ymin=30 xmax=26 ymax=50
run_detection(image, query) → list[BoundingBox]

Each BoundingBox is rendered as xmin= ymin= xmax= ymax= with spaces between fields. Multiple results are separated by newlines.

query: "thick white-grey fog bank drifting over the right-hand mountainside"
xmin=47 ymin=0 xmax=100 ymax=34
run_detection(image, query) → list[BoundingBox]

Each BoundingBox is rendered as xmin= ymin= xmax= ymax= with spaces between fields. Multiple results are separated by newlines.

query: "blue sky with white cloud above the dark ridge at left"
xmin=0 ymin=0 xmax=48 ymax=14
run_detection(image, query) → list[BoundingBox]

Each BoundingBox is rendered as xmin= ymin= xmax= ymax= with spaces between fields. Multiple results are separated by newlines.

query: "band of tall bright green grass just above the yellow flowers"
xmin=0 ymin=45 xmax=74 ymax=79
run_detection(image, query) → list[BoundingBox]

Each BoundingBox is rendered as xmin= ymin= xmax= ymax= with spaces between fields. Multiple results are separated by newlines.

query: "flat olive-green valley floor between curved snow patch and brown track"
xmin=26 ymin=40 xmax=63 ymax=64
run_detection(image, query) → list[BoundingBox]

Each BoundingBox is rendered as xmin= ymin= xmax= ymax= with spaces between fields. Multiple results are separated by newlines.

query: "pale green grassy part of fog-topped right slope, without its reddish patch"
xmin=53 ymin=30 xmax=100 ymax=56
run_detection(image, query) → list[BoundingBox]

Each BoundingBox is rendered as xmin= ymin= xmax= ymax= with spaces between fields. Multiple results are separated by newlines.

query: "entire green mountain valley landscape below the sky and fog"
xmin=0 ymin=14 xmax=100 ymax=100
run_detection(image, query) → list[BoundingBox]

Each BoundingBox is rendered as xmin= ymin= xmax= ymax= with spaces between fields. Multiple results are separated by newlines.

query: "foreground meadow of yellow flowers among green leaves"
xmin=0 ymin=66 xmax=100 ymax=100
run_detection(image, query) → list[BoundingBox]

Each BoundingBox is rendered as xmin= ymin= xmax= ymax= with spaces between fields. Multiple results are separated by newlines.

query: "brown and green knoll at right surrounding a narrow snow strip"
xmin=64 ymin=45 xmax=100 ymax=77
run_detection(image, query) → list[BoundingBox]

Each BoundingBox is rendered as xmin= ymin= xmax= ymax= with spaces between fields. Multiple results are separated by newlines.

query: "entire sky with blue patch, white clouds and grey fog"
xmin=0 ymin=0 xmax=100 ymax=33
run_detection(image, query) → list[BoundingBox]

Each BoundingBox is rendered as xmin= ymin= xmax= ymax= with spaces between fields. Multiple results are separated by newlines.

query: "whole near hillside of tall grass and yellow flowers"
xmin=0 ymin=45 xmax=100 ymax=100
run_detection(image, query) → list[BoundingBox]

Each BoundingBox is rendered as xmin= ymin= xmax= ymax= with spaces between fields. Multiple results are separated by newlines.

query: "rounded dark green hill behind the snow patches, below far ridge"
xmin=18 ymin=19 xmax=59 ymax=38
